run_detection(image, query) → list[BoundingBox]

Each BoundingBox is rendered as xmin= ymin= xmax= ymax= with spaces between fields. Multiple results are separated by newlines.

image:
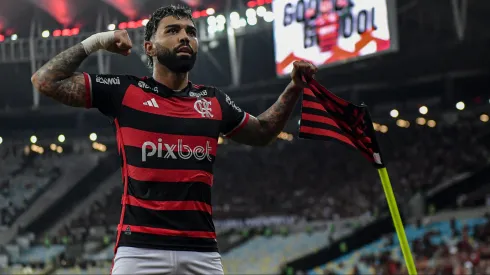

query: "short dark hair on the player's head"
xmin=145 ymin=5 xmax=195 ymax=68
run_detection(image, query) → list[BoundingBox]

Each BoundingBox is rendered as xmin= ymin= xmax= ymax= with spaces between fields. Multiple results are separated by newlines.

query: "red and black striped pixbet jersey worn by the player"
xmin=84 ymin=74 xmax=249 ymax=252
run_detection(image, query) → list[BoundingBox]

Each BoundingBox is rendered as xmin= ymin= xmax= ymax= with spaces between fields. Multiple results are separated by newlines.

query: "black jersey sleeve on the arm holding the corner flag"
xmin=216 ymin=89 xmax=250 ymax=137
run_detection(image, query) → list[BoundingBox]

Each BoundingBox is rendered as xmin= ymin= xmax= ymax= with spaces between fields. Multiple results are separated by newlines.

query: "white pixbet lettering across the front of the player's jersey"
xmin=141 ymin=138 xmax=212 ymax=162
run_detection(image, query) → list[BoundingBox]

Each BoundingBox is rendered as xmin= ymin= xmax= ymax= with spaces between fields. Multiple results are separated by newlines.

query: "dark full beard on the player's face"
xmin=155 ymin=44 xmax=197 ymax=73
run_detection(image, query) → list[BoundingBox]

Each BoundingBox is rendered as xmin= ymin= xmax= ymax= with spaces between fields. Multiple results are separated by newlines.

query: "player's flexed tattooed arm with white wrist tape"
xmin=31 ymin=30 xmax=132 ymax=107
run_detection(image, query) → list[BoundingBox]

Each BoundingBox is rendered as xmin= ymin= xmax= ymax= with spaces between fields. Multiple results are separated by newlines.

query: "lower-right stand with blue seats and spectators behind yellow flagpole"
xmin=308 ymin=208 xmax=490 ymax=275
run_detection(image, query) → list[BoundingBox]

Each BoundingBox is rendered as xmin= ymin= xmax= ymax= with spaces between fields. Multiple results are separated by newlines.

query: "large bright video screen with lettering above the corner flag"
xmin=272 ymin=0 xmax=398 ymax=76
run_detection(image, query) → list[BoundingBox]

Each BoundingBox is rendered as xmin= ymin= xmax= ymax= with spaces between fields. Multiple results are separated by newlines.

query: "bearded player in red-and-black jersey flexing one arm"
xmin=32 ymin=6 xmax=317 ymax=275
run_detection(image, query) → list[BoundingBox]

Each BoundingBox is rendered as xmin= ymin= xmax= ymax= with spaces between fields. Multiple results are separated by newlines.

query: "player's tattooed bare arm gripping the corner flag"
xmin=227 ymin=61 xmax=317 ymax=146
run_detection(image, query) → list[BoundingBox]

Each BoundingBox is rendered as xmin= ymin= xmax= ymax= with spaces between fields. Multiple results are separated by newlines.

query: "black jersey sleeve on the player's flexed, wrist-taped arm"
xmin=83 ymin=73 xmax=130 ymax=118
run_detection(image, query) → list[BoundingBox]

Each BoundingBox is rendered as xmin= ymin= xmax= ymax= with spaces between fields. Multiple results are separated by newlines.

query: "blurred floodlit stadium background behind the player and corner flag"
xmin=0 ymin=0 xmax=490 ymax=275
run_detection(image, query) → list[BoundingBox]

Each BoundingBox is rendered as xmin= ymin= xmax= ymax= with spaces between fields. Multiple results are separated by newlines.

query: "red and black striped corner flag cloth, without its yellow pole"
xmin=299 ymin=79 xmax=384 ymax=168
